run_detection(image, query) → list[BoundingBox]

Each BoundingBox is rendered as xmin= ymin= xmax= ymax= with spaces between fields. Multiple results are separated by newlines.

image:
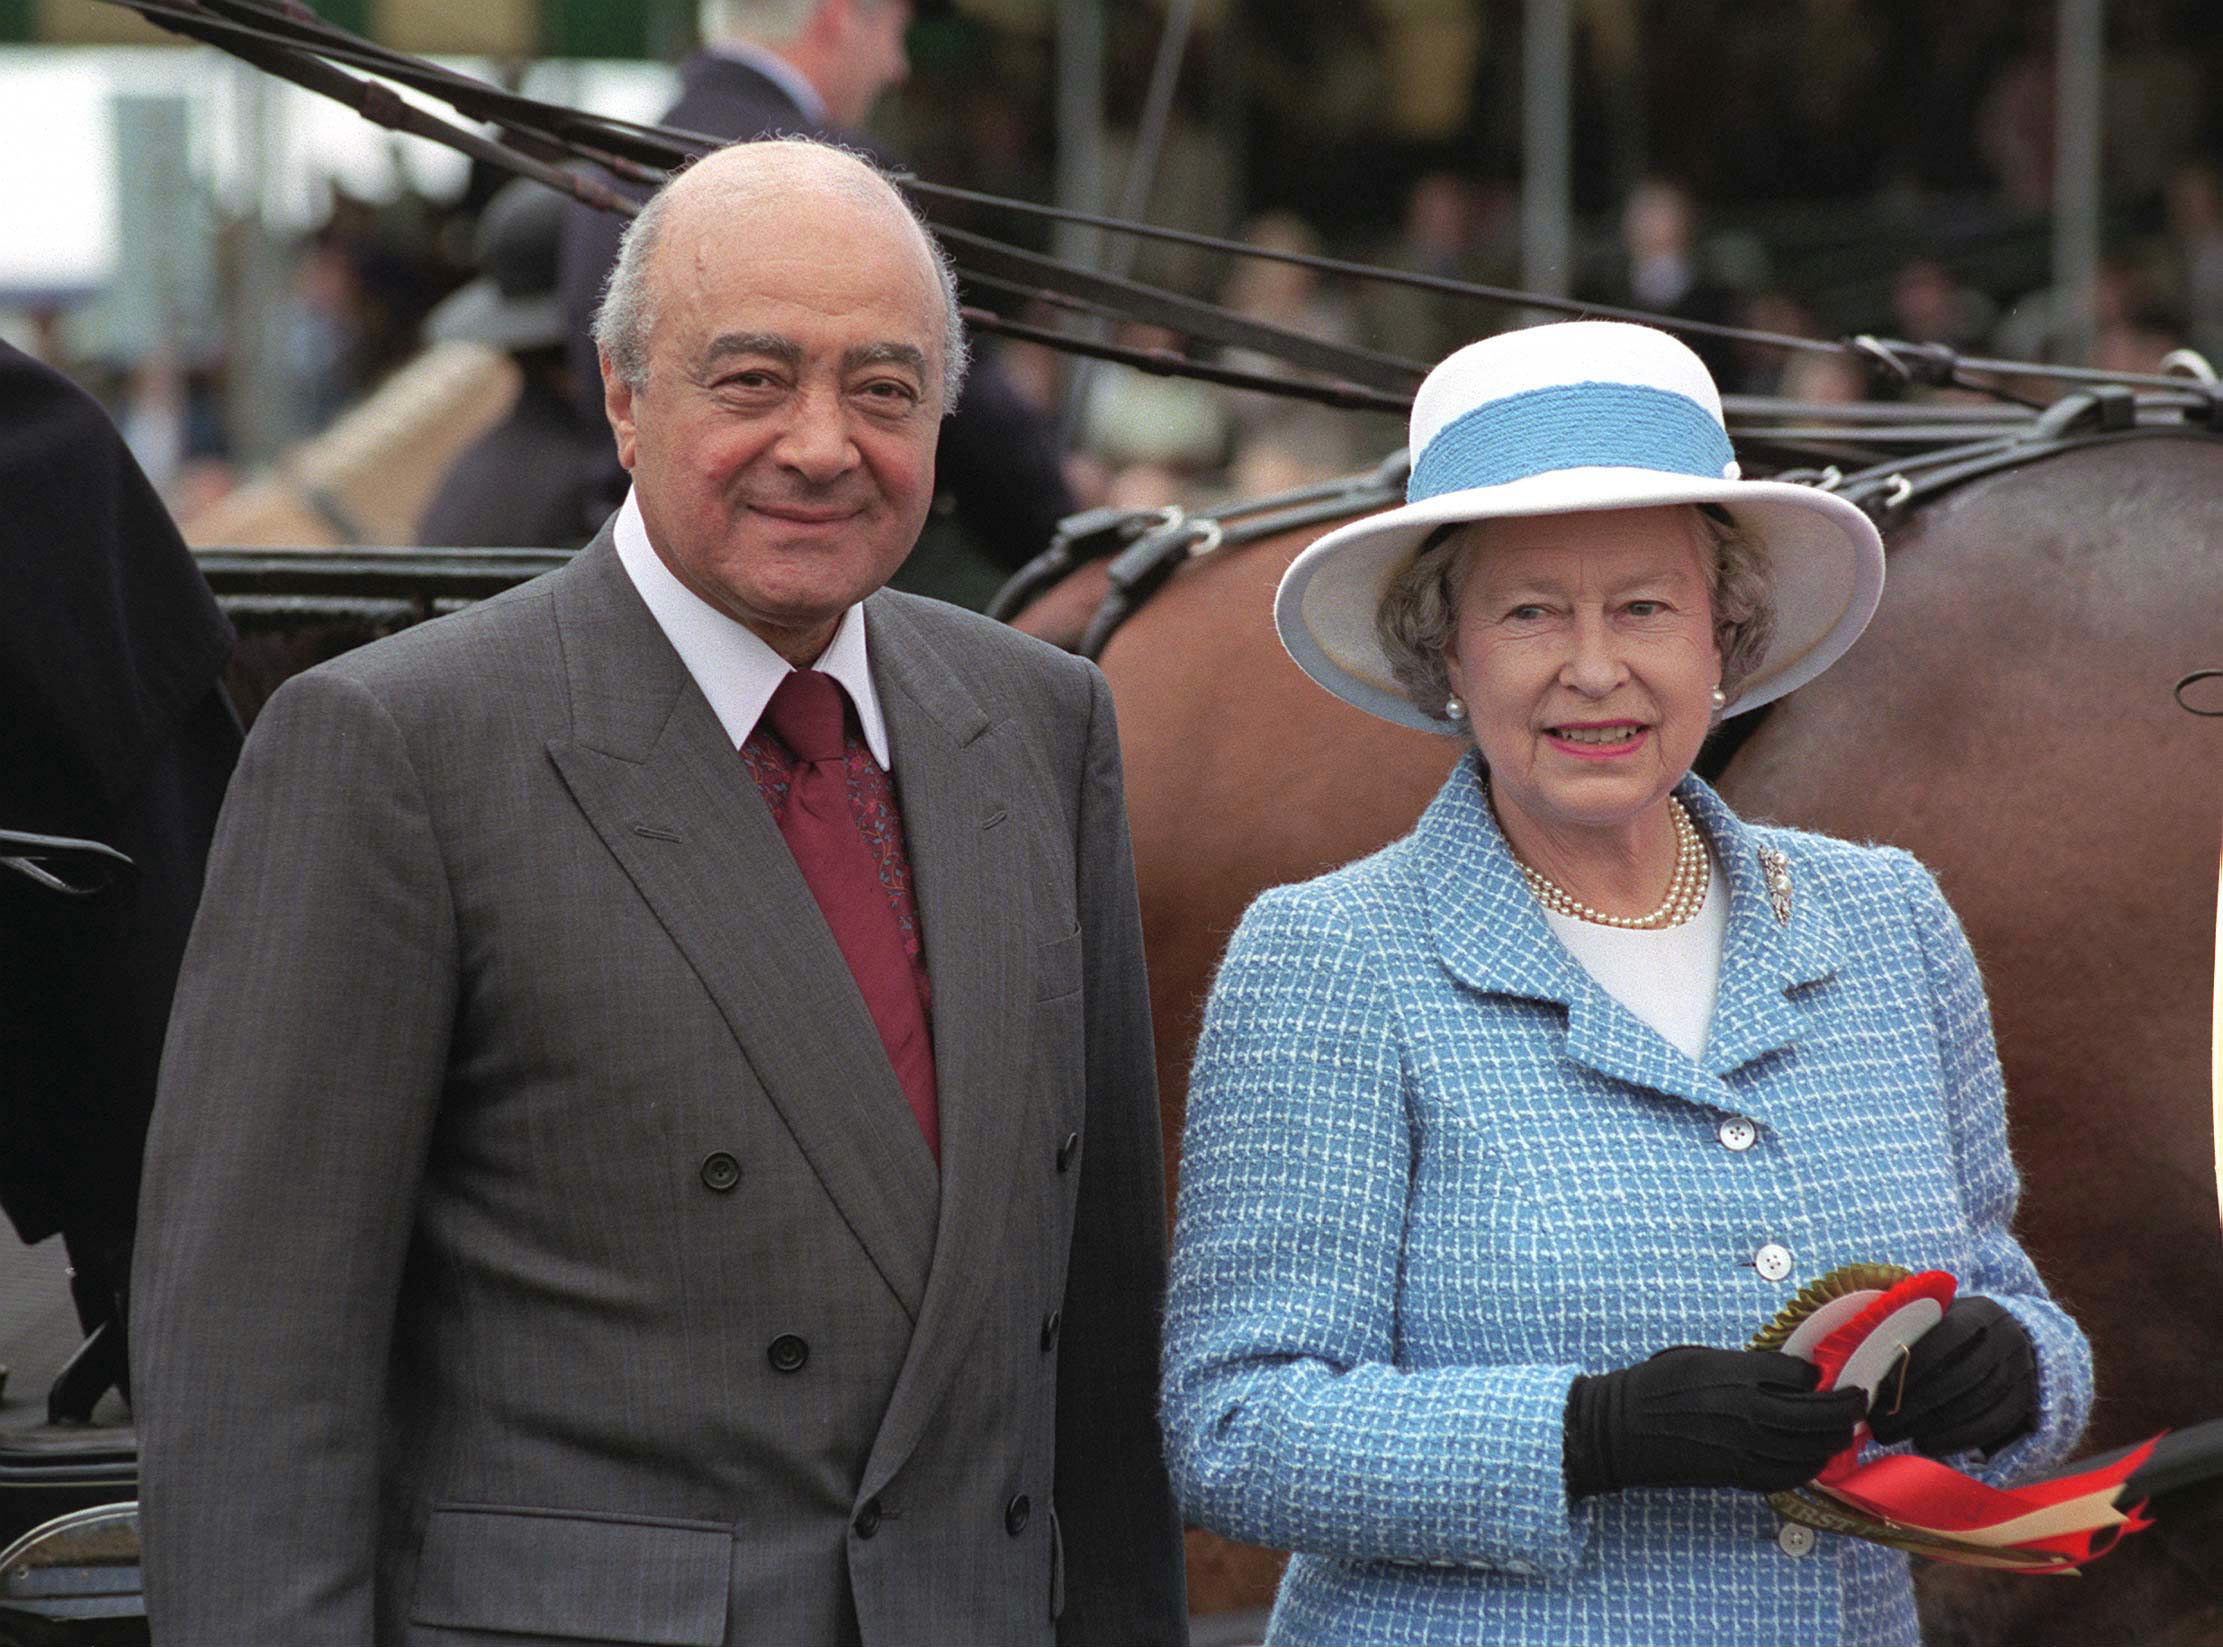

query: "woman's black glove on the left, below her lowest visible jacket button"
xmin=1567 ymin=1345 xmax=1867 ymax=1500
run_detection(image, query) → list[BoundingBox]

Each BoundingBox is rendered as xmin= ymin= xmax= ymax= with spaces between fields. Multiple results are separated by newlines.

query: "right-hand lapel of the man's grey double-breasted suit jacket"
xmin=865 ymin=598 xmax=1031 ymax=1491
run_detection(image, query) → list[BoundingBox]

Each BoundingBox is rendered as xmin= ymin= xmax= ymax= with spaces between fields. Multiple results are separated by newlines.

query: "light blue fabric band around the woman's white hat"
xmin=1405 ymin=382 xmax=1736 ymax=502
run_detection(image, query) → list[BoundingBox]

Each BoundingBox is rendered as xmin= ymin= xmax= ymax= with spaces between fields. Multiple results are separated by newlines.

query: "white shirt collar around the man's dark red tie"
xmin=616 ymin=491 xmax=894 ymax=771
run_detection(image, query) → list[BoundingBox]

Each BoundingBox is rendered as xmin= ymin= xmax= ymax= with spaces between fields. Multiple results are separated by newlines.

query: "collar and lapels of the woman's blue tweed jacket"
xmin=1412 ymin=753 xmax=1843 ymax=1120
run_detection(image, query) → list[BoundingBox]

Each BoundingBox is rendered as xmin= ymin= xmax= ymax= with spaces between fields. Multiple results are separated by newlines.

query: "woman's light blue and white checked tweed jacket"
xmin=1163 ymin=756 xmax=2092 ymax=1645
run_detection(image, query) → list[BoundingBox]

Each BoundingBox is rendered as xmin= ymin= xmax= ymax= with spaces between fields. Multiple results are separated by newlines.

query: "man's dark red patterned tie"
xmin=765 ymin=669 xmax=943 ymax=1160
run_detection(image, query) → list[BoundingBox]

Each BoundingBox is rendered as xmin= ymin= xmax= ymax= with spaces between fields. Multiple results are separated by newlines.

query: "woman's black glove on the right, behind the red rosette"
xmin=1867 ymin=1298 xmax=2038 ymax=1458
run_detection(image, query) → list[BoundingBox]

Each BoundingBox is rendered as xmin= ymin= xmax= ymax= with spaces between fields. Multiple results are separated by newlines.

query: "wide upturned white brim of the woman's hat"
xmin=1274 ymin=467 xmax=1883 ymax=731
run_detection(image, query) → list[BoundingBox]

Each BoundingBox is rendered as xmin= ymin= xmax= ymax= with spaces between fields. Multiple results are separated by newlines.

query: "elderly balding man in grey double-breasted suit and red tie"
xmin=136 ymin=142 xmax=1183 ymax=1647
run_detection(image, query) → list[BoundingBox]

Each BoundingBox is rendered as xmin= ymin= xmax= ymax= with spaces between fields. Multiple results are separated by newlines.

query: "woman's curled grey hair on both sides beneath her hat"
xmin=1374 ymin=507 xmax=1776 ymax=727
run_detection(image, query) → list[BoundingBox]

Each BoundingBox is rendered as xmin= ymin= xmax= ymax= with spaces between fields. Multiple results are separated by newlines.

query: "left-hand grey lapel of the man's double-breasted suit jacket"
xmin=549 ymin=529 xmax=947 ymax=1320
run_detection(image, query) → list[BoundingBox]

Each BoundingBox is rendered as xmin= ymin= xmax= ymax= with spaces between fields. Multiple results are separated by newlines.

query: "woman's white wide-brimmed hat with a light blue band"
xmin=1274 ymin=320 xmax=1883 ymax=731
